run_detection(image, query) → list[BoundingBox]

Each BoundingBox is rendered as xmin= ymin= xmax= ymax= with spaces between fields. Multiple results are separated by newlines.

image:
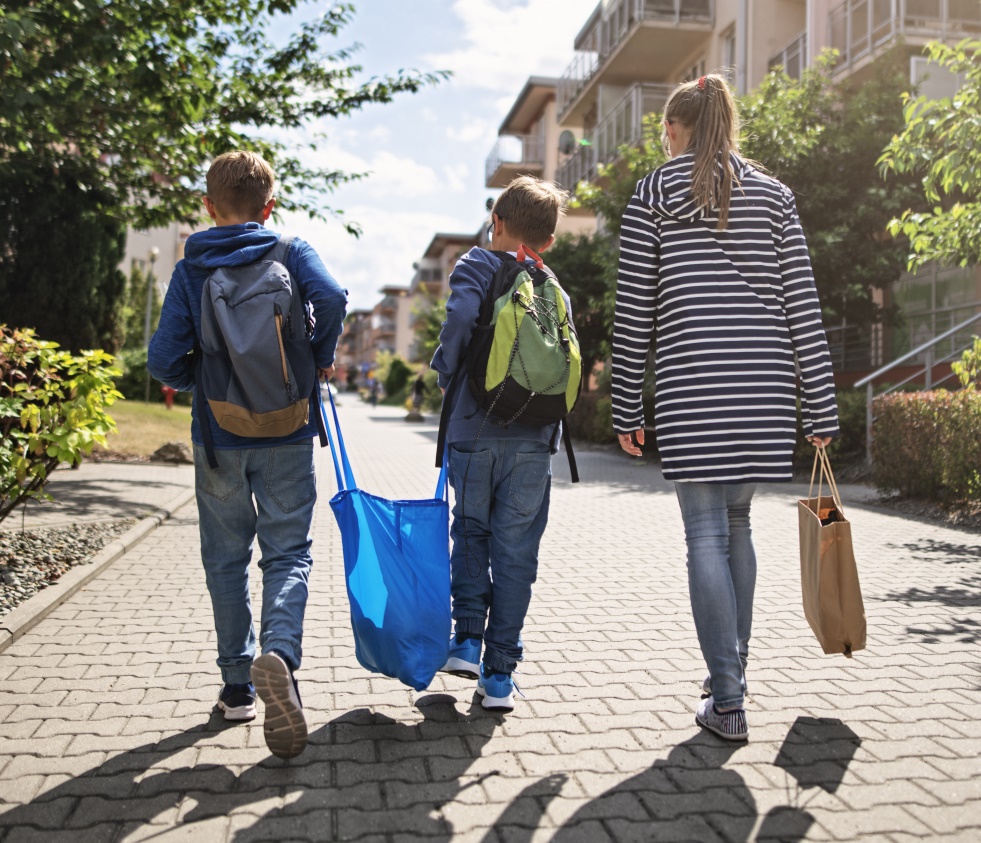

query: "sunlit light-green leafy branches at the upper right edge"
xmin=879 ymin=40 xmax=981 ymax=270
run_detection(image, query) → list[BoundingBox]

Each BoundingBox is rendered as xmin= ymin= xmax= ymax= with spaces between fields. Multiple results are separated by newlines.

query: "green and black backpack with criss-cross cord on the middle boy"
xmin=467 ymin=247 xmax=582 ymax=427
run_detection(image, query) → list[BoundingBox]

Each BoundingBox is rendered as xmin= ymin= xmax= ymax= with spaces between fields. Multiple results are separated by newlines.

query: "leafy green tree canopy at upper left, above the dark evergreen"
xmin=0 ymin=0 xmax=447 ymax=230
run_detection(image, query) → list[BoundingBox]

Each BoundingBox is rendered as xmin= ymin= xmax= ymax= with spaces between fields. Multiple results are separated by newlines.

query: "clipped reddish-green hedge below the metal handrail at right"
xmin=872 ymin=389 xmax=981 ymax=503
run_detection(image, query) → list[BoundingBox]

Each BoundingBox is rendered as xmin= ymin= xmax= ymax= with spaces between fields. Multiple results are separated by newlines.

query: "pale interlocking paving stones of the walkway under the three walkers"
xmin=0 ymin=397 xmax=981 ymax=843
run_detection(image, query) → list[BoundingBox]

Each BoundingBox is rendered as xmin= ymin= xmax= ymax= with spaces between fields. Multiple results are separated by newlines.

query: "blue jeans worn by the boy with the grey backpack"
xmin=194 ymin=440 xmax=317 ymax=684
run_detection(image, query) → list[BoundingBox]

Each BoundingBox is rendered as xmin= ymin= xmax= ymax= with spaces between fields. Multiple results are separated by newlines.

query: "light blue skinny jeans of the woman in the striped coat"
xmin=674 ymin=482 xmax=756 ymax=709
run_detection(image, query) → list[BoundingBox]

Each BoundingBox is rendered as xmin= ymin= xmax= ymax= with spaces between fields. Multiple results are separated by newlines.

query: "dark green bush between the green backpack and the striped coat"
xmin=545 ymin=234 xmax=618 ymax=389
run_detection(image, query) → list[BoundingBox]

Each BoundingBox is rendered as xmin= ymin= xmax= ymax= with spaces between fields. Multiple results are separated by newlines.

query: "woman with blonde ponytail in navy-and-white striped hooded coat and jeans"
xmin=613 ymin=74 xmax=838 ymax=740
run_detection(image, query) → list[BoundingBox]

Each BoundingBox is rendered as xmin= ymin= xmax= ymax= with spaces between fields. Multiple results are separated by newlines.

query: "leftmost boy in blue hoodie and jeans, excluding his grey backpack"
xmin=147 ymin=152 xmax=347 ymax=758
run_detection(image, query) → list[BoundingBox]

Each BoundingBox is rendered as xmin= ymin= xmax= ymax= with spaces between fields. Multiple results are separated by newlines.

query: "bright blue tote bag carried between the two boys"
xmin=321 ymin=396 xmax=450 ymax=691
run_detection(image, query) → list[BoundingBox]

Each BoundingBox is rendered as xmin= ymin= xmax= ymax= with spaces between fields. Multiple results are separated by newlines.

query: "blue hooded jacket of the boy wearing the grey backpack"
xmin=147 ymin=222 xmax=347 ymax=450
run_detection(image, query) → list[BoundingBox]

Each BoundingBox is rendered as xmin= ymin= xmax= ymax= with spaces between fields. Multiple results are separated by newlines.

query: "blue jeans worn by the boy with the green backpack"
xmin=449 ymin=439 xmax=552 ymax=673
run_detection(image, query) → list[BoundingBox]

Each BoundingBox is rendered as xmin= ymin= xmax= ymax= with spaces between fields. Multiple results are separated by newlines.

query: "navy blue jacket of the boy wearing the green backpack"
xmin=431 ymin=247 xmax=569 ymax=453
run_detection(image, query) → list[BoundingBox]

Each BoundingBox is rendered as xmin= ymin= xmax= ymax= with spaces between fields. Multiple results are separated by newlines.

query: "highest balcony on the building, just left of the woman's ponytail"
xmin=557 ymin=0 xmax=715 ymax=125
